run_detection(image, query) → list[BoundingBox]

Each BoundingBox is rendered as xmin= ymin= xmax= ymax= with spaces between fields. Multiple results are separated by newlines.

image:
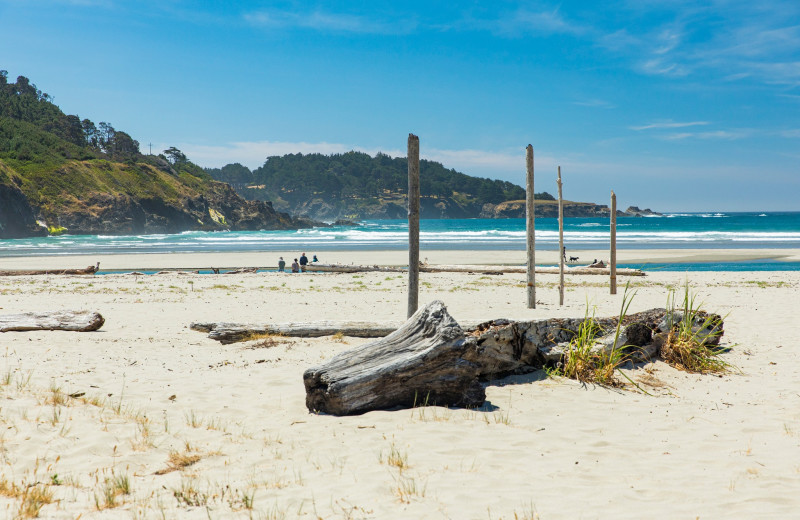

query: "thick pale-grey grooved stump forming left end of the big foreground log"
xmin=303 ymin=301 xmax=486 ymax=415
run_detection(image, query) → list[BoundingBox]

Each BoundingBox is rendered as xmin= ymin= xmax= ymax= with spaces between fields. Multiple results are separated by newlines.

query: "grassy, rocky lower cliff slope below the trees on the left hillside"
xmin=0 ymin=154 xmax=311 ymax=238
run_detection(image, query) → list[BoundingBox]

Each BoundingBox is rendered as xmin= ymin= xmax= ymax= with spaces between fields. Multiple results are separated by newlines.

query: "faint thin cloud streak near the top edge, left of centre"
xmin=243 ymin=10 xmax=416 ymax=34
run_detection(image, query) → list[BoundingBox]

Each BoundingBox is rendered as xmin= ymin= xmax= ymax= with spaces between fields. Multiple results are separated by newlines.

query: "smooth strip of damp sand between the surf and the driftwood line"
xmin=0 ymin=248 xmax=800 ymax=271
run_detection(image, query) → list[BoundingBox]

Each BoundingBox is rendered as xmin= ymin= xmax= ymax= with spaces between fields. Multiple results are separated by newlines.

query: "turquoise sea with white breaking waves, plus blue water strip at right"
xmin=0 ymin=212 xmax=800 ymax=270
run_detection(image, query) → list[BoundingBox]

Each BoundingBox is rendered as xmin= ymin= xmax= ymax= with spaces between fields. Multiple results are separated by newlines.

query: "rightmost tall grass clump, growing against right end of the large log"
xmin=661 ymin=281 xmax=735 ymax=374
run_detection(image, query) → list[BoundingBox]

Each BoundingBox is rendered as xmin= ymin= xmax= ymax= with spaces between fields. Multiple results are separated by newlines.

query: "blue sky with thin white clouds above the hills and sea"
xmin=0 ymin=0 xmax=800 ymax=211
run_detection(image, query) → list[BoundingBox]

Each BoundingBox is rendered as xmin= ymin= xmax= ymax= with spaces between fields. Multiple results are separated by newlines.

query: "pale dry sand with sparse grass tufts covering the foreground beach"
xmin=0 ymin=252 xmax=800 ymax=520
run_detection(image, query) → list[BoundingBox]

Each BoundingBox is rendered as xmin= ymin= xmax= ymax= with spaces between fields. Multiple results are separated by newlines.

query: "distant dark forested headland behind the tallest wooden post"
xmin=206 ymin=152 xmax=555 ymax=220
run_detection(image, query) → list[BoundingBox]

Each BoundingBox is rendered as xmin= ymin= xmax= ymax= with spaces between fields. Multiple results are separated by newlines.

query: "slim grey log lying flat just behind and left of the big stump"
xmin=189 ymin=321 xmax=402 ymax=345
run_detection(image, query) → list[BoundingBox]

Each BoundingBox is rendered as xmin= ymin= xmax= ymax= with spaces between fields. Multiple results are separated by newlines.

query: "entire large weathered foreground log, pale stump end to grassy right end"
xmin=303 ymin=301 xmax=723 ymax=415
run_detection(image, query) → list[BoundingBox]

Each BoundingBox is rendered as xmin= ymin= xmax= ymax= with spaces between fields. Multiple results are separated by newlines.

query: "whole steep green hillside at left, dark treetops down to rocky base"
xmin=0 ymin=71 xmax=306 ymax=238
